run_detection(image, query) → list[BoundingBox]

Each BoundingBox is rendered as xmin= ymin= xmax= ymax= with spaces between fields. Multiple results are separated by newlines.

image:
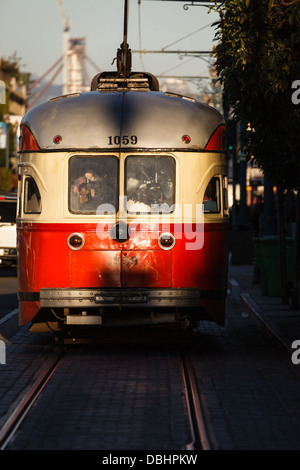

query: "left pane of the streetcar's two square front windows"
xmin=69 ymin=156 xmax=119 ymax=214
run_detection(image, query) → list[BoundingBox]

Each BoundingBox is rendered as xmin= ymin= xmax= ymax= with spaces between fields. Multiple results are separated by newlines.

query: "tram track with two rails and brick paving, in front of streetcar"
xmin=0 ymin=336 xmax=216 ymax=451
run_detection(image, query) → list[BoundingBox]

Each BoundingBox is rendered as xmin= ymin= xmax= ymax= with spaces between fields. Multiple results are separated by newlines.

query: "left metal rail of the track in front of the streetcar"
xmin=0 ymin=353 xmax=62 ymax=450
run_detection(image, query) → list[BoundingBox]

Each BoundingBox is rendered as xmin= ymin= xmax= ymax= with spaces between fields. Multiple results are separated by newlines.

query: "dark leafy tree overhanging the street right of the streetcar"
xmin=214 ymin=0 xmax=300 ymax=303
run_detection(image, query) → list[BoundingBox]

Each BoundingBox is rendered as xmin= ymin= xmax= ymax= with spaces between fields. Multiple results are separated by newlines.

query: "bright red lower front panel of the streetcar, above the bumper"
xmin=18 ymin=224 xmax=227 ymax=324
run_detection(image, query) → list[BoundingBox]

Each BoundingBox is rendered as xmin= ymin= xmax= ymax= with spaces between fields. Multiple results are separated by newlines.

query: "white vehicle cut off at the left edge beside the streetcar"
xmin=0 ymin=193 xmax=17 ymax=266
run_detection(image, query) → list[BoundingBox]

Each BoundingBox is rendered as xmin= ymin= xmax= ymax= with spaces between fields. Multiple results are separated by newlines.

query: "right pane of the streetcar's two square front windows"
xmin=125 ymin=156 xmax=175 ymax=213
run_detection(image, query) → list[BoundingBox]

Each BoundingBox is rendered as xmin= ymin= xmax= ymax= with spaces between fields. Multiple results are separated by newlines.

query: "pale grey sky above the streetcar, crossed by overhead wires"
xmin=0 ymin=0 xmax=218 ymax=93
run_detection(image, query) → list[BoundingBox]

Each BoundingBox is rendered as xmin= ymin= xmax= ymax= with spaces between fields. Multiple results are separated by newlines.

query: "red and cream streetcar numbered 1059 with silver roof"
xmin=17 ymin=31 xmax=229 ymax=334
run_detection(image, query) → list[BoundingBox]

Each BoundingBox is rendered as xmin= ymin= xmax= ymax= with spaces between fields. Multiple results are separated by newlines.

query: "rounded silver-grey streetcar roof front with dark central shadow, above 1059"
xmin=21 ymin=90 xmax=224 ymax=151
